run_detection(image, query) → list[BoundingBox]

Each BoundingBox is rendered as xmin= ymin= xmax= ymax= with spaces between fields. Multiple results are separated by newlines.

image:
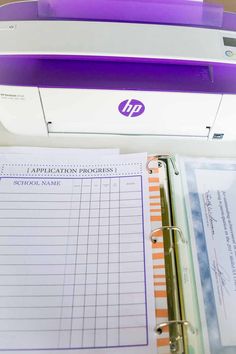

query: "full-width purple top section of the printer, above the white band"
xmin=0 ymin=0 xmax=230 ymax=30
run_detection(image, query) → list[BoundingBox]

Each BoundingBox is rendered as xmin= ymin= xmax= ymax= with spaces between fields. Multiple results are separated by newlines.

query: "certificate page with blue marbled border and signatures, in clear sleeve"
xmin=182 ymin=159 xmax=236 ymax=354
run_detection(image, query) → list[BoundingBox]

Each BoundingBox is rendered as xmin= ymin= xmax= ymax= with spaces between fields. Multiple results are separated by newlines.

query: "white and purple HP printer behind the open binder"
xmin=0 ymin=1 xmax=236 ymax=156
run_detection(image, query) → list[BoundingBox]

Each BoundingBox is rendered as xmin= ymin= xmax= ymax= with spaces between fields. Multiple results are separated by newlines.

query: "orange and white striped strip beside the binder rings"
xmin=149 ymin=168 xmax=170 ymax=354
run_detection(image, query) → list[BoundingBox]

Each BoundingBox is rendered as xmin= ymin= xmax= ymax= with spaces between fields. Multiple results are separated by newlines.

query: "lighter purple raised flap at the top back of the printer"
xmin=38 ymin=0 xmax=224 ymax=27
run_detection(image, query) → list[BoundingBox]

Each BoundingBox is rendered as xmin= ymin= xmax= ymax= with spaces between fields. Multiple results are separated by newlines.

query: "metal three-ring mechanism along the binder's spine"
xmin=147 ymin=155 xmax=194 ymax=353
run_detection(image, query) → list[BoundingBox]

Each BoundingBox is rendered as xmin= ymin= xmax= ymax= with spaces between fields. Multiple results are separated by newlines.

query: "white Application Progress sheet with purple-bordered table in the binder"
xmin=0 ymin=154 xmax=156 ymax=354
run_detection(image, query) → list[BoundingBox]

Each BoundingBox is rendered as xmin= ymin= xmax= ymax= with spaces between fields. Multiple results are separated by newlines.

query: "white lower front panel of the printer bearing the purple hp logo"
xmin=0 ymin=86 xmax=229 ymax=139
